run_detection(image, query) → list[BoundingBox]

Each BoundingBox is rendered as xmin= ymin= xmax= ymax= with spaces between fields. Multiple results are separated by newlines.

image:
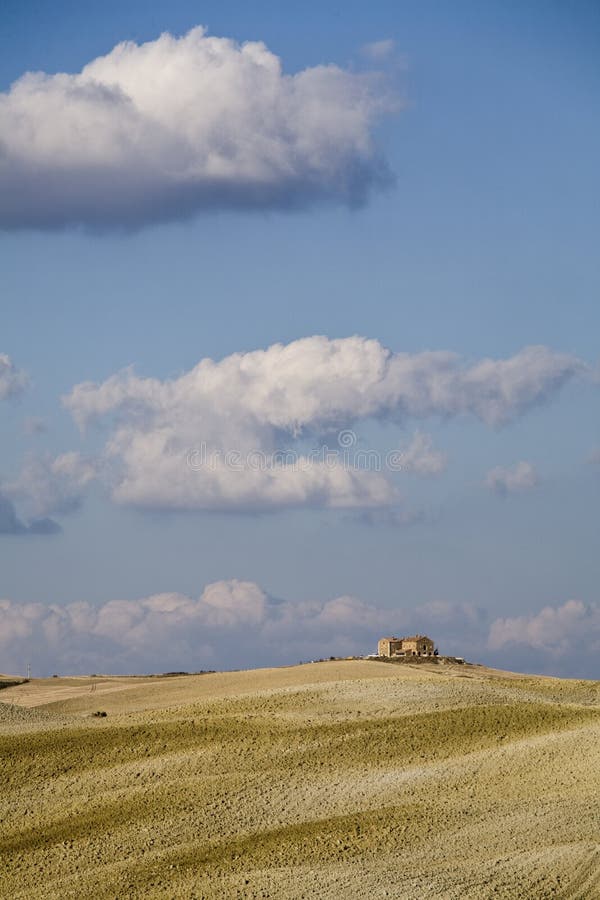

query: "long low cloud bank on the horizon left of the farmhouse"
xmin=0 ymin=579 xmax=384 ymax=674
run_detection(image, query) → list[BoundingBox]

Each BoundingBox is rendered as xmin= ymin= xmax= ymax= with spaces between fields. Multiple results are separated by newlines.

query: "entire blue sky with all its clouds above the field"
xmin=0 ymin=0 xmax=600 ymax=678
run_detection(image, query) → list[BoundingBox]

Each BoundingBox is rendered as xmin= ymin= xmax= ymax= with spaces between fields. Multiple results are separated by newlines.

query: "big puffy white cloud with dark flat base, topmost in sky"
xmin=0 ymin=27 xmax=392 ymax=228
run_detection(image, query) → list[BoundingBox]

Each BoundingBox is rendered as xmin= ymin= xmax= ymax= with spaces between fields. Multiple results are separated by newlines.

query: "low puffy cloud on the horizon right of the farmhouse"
xmin=488 ymin=600 xmax=600 ymax=661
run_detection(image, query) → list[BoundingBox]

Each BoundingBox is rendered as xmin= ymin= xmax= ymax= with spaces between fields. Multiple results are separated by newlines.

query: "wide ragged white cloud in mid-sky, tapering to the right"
xmin=65 ymin=337 xmax=584 ymax=510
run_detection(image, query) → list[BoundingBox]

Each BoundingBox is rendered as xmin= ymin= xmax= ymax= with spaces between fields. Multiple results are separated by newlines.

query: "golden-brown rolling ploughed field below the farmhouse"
xmin=0 ymin=660 xmax=600 ymax=900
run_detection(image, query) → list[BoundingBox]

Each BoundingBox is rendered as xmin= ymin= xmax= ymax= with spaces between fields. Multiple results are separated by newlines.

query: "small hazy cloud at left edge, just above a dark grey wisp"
xmin=3 ymin=452 xmax=97 ymax=518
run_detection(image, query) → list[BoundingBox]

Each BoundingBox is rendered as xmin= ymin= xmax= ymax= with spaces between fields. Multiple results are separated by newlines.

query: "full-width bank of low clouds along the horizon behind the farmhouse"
xmin=0 ymin=579 xmax=600 ymax=677
